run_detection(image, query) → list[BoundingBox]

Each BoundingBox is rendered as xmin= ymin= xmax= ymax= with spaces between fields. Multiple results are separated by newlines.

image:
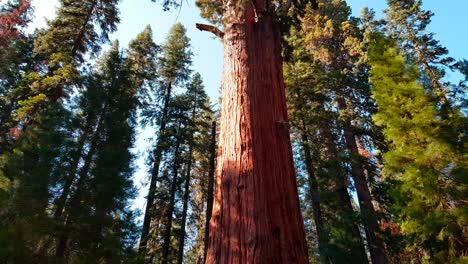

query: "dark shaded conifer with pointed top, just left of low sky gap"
xmin=55 ymin=43 xmax=139 ymax=262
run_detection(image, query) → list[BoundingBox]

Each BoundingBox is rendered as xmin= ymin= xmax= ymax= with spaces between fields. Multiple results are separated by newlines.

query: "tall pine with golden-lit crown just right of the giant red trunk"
xmin=288 ymin=1 xmax=386 ymax=263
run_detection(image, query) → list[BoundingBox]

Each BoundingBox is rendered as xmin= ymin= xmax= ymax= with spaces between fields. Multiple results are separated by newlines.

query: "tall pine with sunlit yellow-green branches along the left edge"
xmin=1 ymin=1 xmax=123 ymax=256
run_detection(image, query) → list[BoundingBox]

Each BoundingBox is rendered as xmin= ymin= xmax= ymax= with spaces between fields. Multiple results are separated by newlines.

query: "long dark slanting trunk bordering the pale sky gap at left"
xmin=138 ymin=82 xmax=172 ymax=254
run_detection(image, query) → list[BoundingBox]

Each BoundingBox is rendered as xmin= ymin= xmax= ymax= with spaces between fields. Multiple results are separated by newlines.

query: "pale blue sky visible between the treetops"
xmin=31 ymin=0 xmax=468 ymax=217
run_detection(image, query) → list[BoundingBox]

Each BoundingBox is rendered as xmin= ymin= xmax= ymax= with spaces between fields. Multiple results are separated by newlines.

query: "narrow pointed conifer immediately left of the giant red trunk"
xmin=145 ymin=74 xmax=211 ymax=263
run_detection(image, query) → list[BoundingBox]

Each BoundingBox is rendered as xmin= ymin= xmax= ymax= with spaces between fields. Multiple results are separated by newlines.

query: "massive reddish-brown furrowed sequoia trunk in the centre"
xmin=206 ymin=5 xmax=308 ymax=264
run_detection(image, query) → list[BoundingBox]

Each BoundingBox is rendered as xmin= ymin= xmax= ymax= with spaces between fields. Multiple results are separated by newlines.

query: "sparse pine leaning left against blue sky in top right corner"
xmin=385 ymin=0 xmax=467 ymax=161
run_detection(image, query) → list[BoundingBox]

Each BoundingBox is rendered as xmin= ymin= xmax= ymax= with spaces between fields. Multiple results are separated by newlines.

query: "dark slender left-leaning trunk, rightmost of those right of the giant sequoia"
xmin=338 ymin=98 xmax=388 ymax=264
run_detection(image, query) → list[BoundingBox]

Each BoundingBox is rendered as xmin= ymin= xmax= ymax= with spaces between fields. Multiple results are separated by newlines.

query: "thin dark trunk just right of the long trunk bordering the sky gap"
xmin=161 ymin=123 xmax=182 ymax=264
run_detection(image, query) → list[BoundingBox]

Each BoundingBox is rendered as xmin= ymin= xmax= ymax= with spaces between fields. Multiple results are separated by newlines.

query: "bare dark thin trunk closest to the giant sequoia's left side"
xmin=203 ymin=121 xmax=216 ymax=263
